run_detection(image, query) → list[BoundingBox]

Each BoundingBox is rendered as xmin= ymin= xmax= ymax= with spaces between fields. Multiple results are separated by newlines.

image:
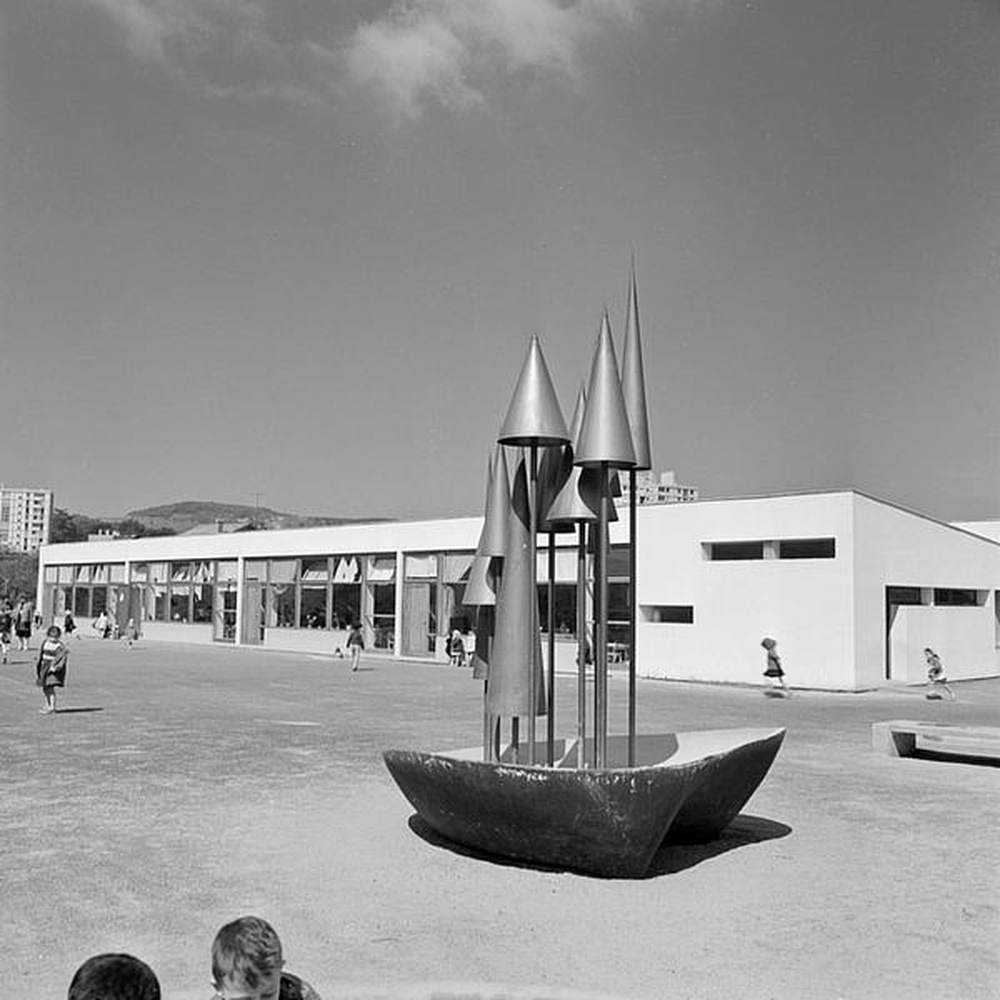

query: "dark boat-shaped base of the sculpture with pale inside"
xmin=384 ymin=729 xmax=785 ymax=878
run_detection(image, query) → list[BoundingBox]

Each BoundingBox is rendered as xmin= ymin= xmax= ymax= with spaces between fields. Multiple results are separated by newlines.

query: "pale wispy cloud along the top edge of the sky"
xmin=80 ymin=0 xmax=648 ymax=120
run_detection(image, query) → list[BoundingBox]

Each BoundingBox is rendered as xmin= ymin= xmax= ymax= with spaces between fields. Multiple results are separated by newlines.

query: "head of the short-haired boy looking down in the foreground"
xmin=212 ymin=917 xmax=285 ymax=1000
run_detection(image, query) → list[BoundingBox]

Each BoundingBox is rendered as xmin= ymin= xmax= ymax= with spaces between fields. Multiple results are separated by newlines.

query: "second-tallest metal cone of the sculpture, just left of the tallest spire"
xmin=573 ymin=309 xmax=635 ymax=469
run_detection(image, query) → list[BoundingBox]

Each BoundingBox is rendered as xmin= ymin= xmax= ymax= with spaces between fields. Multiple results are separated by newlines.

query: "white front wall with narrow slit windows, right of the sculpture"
xmin=636 ymin=493 xmax=855 ymax=689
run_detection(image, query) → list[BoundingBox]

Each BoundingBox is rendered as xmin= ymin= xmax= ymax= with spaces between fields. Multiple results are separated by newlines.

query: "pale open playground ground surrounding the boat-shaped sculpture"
xmin=0 ymin=638 xmax=1000 ymax=1000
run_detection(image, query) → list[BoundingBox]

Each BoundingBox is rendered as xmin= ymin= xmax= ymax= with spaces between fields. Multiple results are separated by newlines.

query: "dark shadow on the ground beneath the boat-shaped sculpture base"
xmin=408 ymin=813 xmax=792 ymax=880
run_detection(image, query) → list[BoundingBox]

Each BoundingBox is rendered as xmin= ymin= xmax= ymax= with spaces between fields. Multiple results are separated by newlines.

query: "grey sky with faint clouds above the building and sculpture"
xmin=0 ymin=0 xmax=1000 ymax=520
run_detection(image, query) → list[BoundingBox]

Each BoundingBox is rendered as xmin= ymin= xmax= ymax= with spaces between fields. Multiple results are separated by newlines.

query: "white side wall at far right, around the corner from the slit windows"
xmin=854 ymin=494 xmax=1000 ymax=685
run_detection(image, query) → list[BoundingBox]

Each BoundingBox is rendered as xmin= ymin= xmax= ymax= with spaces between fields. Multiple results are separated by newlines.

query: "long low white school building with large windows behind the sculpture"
xmin=38 ymin=490 xmax=1000 ymax=690
